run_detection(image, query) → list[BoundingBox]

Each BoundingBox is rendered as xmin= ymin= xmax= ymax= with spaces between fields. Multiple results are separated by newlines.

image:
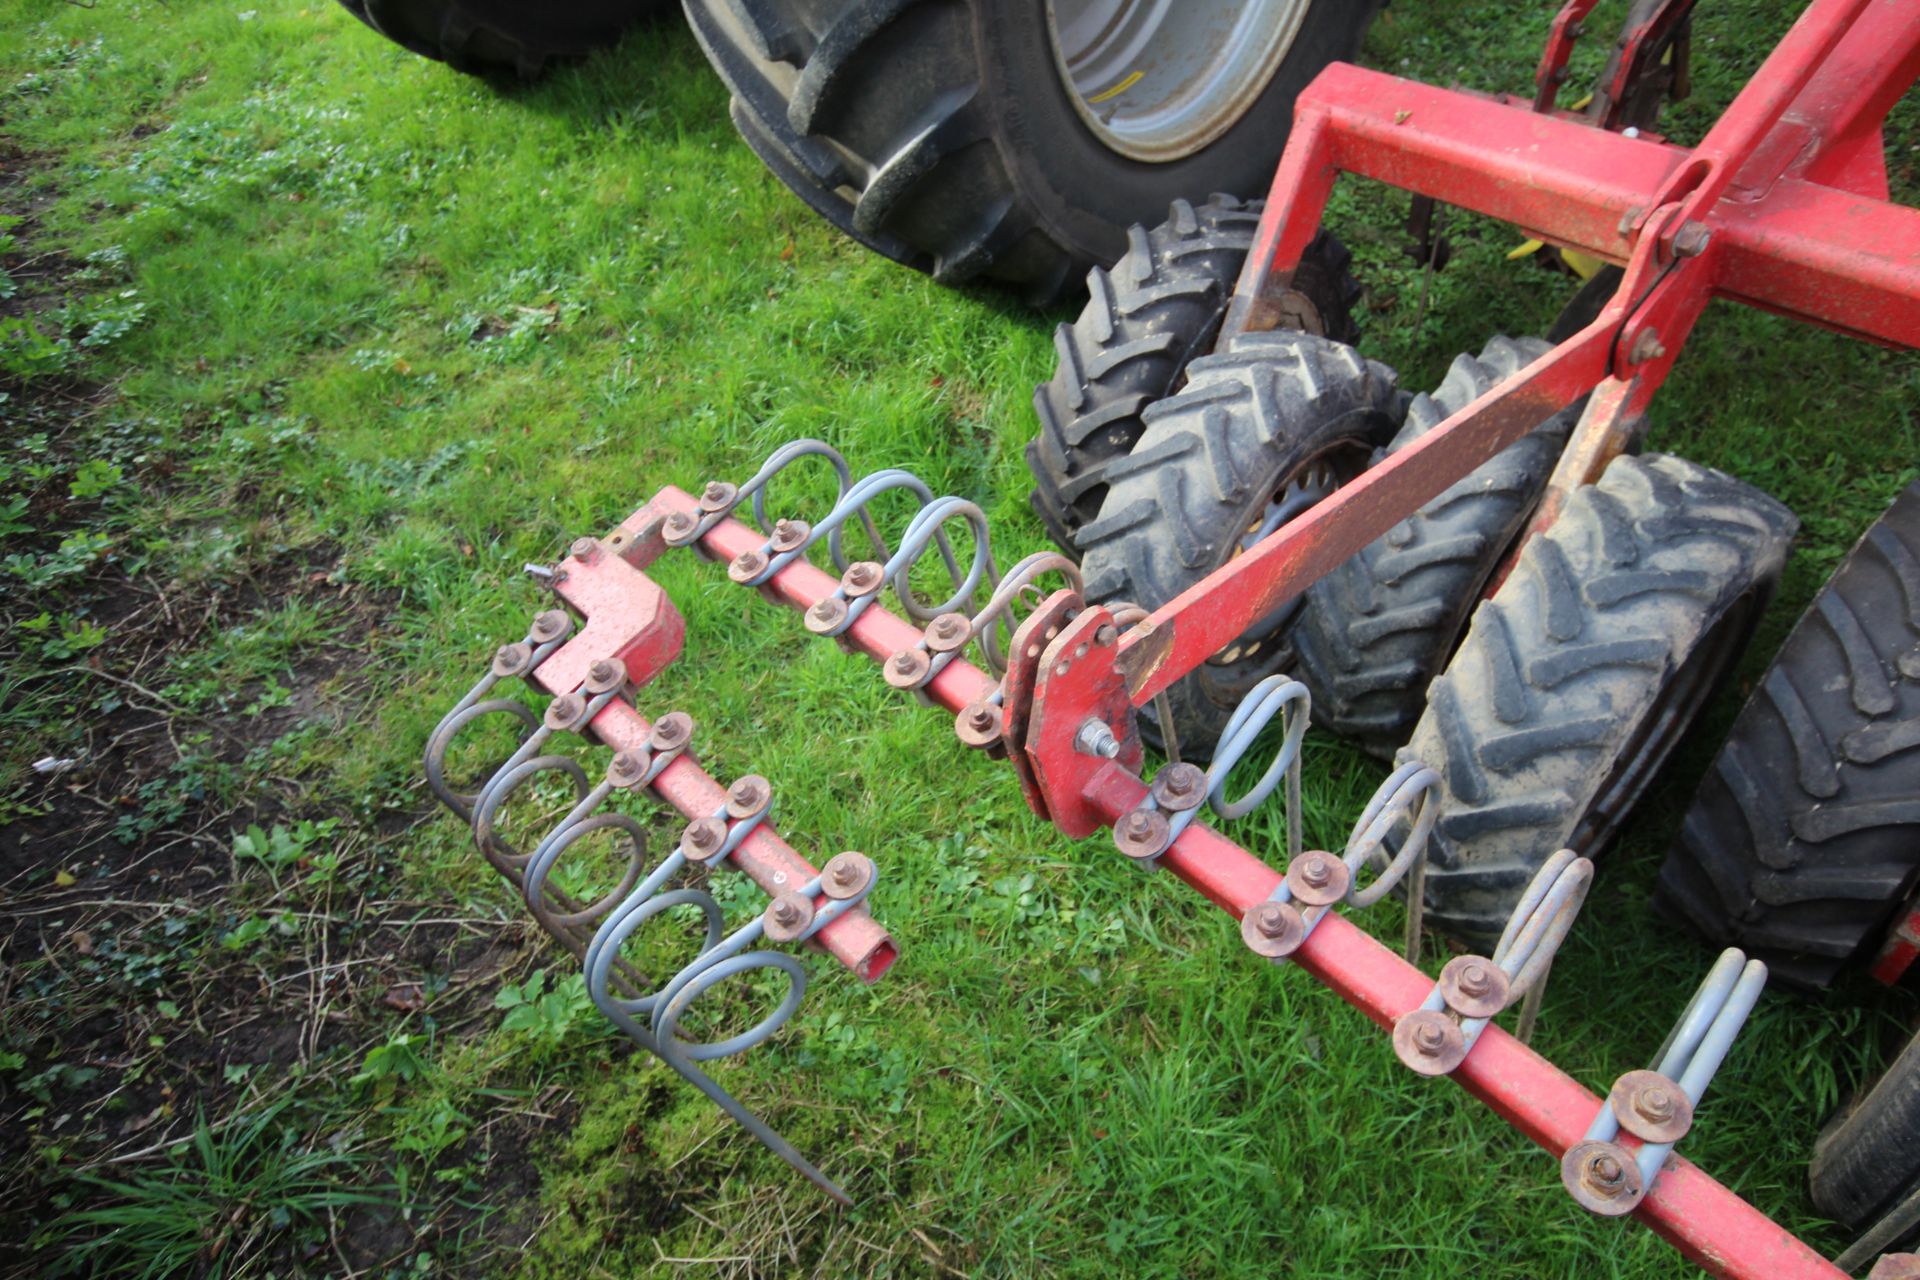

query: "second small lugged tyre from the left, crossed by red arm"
xmin=1079 ymin=330 xmax=1405 ymax=760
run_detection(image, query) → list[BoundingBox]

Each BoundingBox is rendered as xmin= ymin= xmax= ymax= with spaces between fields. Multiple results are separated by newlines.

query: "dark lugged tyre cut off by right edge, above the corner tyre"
xmin=1655 ymin=482 xmax=1920 ymax=988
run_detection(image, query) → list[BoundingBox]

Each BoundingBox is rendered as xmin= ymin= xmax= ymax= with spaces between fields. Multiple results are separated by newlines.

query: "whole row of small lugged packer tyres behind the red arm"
xmin=1027 ymin=196 xmax=1920 ymax=1251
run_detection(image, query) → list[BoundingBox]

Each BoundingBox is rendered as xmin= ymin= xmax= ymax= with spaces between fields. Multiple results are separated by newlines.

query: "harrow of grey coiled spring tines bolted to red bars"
xmin=426 ymin=439 xmax=1764 ymax=1258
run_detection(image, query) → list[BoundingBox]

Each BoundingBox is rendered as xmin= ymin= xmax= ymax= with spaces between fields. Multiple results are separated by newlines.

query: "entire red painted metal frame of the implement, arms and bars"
xmin=541 ymin=0 xmax=1920 ymax=1280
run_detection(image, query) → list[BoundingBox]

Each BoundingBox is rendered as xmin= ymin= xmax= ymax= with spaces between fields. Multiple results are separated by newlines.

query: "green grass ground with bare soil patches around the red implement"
xmin=0 ymin=0 xmax=1920 ymax=1278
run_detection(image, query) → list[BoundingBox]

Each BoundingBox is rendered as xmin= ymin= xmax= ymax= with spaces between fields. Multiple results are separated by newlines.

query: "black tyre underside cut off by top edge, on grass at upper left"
xmin=340 ymin=0 xmax=670 ymax=81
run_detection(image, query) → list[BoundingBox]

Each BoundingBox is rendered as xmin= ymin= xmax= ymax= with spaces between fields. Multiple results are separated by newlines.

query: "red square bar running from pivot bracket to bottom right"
xmin=1087 ymin=766 xmax=1845 ymax=1280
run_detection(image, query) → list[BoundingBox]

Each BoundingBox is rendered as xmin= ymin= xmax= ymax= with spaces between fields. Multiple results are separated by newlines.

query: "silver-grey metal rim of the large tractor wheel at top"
xmin=1046 ymin=0 xmax=1313 ymax=163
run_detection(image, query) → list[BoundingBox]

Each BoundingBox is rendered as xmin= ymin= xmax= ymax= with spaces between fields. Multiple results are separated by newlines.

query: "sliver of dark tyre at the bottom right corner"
xmin=1807 ymin=1036 xmax=1920 ymax=1228
